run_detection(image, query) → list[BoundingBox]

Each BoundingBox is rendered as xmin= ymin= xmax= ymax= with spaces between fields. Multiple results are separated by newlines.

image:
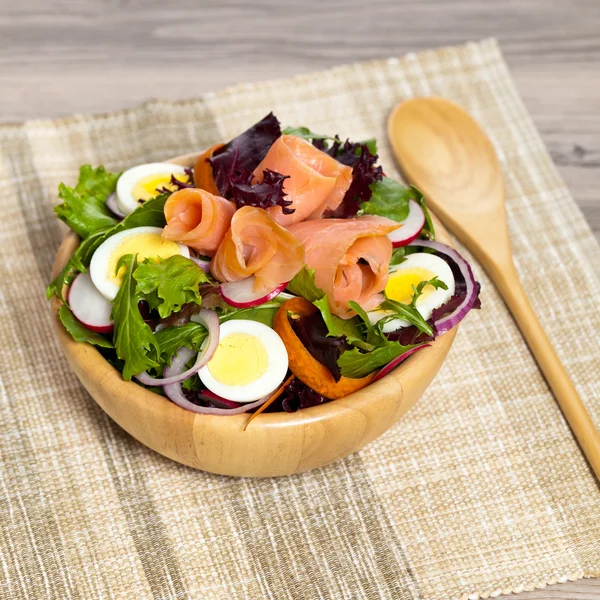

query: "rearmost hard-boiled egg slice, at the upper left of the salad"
xmin=117 ymin=163 xmax=187 ymax=215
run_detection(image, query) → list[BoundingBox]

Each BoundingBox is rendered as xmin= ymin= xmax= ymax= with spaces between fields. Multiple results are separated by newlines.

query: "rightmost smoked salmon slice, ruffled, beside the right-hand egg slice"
xmin=289 ymin=215 xmax=400 ymax=319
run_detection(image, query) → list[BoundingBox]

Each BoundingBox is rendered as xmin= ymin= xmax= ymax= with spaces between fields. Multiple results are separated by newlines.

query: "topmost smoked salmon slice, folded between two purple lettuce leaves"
xmin=254 ymin=135 xmax=352 ymax=227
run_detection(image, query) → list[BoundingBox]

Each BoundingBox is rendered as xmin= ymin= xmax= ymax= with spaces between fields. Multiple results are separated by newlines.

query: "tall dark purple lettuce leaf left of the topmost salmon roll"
xmin=209 ymin=112 xmax=281 ymax=198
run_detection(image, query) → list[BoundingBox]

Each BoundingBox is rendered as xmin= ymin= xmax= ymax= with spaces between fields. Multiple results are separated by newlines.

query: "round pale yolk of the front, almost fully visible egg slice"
xmin=208 ymin=333 xmax=269 ymax=386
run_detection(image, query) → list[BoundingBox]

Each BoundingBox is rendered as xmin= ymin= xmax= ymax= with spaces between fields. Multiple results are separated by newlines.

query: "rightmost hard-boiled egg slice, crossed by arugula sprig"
xmin=369 ymin=252 xmax=454 ymax=333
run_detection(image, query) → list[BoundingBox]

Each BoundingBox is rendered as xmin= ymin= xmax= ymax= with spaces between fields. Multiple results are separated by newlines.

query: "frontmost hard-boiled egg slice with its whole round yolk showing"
xmin=198 ymin=319 xmax=288 ymax=402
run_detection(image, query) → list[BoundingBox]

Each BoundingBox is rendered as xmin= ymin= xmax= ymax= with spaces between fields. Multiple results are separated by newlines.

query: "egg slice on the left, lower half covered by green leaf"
xmin=90 ymin=227 xmax=190 ymax=300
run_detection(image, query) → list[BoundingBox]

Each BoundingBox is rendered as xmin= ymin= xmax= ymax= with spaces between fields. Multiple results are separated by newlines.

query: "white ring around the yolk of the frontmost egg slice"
xmin=198 ymin=319 xmax=288 ymax=402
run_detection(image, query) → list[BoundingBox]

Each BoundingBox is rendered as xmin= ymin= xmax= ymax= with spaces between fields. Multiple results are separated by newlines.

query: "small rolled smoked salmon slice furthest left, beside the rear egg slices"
xmin=162 ymin=188 xmax=235 ymax=256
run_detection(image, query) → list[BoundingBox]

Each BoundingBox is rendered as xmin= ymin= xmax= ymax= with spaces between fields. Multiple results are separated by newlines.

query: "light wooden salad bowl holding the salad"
xmin=51 ymin=155 xmax=456 ymax=477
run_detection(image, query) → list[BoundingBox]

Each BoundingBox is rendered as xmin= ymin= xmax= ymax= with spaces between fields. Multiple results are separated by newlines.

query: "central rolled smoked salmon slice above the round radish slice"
xmin=210 ymin=206 xmax=304 ymax=292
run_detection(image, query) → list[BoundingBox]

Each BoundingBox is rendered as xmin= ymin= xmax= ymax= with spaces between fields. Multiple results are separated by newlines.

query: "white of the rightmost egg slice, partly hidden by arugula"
xmin=369 ymin=252 xmax=455 ymax=333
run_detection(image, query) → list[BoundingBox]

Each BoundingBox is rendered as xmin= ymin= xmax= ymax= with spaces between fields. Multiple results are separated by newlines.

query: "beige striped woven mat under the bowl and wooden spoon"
xmin=0 ymin=41 xmax=600 ymax=600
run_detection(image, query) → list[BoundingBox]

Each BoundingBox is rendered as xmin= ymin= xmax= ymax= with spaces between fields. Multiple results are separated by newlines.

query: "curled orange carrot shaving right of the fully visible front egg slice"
xmin=273 ymin=298 xmax=375 ymax=400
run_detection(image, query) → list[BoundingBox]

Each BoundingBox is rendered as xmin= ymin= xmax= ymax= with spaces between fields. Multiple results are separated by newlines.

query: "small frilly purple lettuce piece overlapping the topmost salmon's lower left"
xmin=229 ymin=169 xmax=295 ymax=215
